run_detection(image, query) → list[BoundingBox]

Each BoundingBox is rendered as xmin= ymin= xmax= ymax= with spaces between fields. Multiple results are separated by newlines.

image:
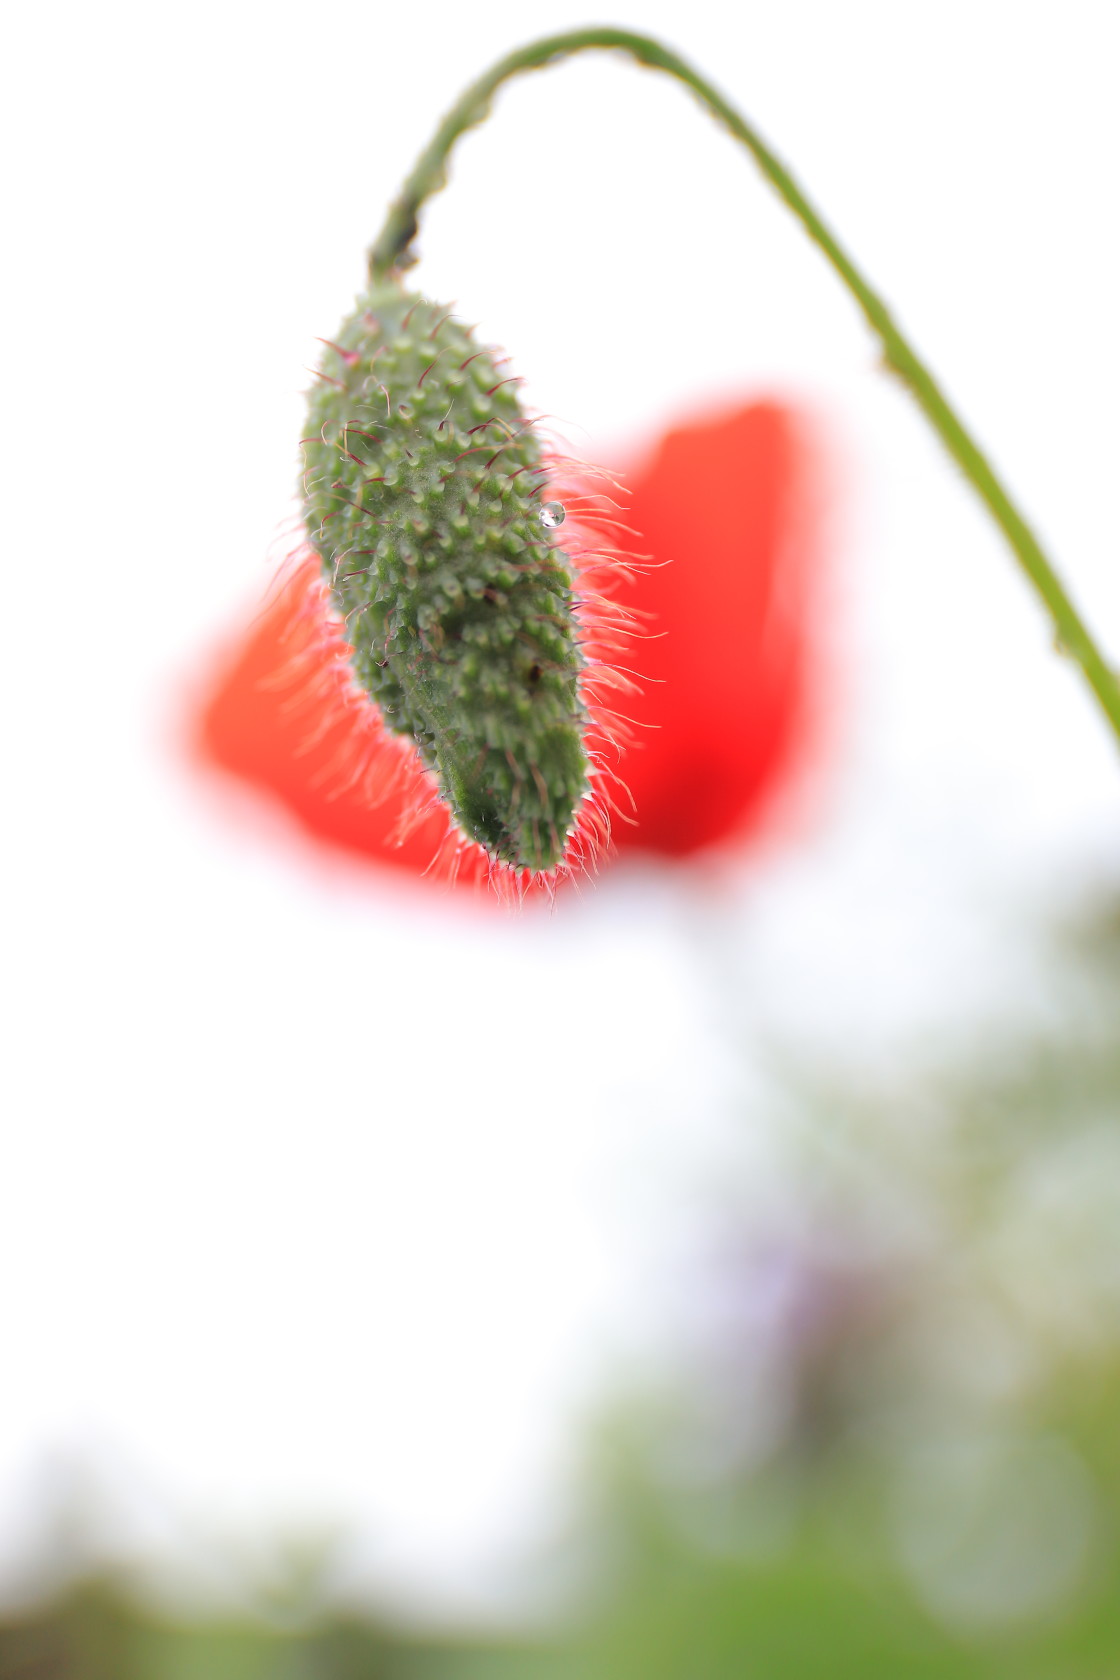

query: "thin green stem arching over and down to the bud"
xmin=369 ymin=29 xmax=1120 ymax=739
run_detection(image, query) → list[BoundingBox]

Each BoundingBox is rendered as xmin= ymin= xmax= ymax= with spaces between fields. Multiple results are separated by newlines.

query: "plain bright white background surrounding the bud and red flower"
xmin=0 ymin=0 xmax=1120 ymax=1608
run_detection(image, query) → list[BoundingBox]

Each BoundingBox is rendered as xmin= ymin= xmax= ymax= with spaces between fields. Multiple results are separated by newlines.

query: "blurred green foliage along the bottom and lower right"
xmin=8 ymin=906 xmax=1120 ymax=1680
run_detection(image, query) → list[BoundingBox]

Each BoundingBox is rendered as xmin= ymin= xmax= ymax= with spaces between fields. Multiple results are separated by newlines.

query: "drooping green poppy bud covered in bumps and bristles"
xmin=304 ymin=277 xmax=593 ymax=874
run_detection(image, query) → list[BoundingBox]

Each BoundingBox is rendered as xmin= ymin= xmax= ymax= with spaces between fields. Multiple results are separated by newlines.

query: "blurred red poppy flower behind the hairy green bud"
xmin=196 ymin=402 xmax=814 ymax=884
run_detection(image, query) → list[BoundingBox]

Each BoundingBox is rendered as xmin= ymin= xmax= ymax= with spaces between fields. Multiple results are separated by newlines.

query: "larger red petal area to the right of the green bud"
xmin=616 ymin=403 xmax=809 ymax=857
